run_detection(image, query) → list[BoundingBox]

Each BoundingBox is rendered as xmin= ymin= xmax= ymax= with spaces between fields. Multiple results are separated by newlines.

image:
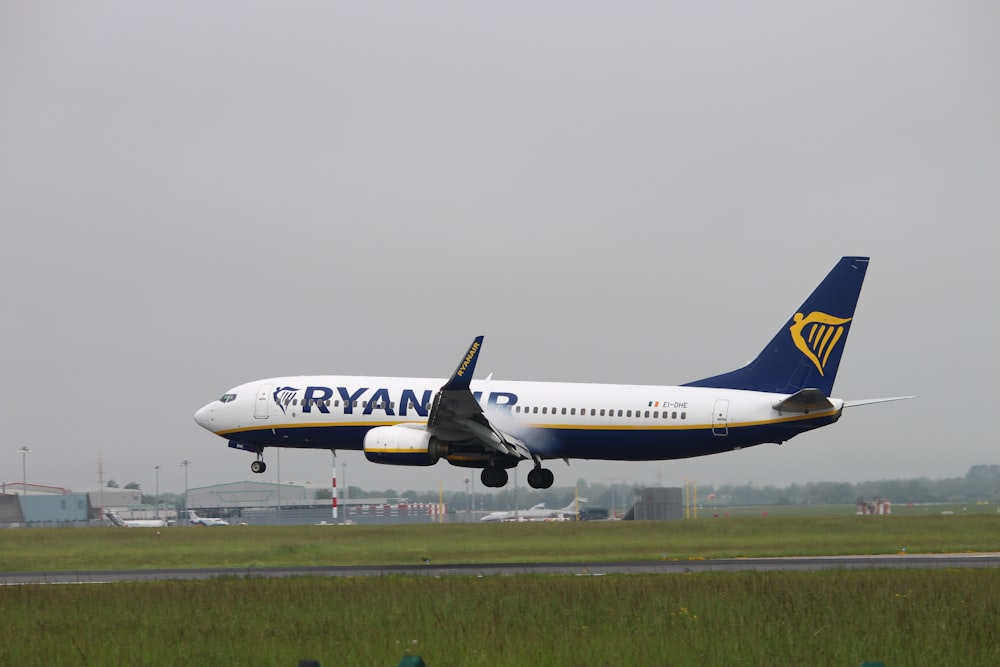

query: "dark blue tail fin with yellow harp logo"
xmin=684 ymin=257 xmax=868 ymax=396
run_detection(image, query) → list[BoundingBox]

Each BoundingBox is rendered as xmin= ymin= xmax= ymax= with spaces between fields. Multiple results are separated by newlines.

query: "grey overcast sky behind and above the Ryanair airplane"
xmin=0 ymin=0 xmax=1000 ymax=491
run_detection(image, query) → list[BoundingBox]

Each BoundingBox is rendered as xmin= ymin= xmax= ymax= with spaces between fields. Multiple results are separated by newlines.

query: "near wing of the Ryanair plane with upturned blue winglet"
xmin=427 ymin=336 xmax=531 ymax=459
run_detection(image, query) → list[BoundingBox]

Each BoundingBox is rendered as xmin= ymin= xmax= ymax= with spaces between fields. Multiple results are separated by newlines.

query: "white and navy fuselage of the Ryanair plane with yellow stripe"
xmin=195 ymin=376 xmax=843 ymax=460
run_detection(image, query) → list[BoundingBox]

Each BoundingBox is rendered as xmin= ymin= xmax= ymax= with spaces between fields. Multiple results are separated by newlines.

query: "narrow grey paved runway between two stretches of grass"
xmin=0 ymin=552 xmax=1000 ymax=585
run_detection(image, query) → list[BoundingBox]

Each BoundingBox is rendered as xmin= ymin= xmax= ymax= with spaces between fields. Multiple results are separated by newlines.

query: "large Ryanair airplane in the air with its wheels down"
xmin=194 ymin=256 xmax=913 ymax=489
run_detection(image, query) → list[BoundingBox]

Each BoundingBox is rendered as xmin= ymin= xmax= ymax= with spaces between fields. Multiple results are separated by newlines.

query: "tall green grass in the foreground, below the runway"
xmin=0 ymin=570 xmax=1000 ymax=667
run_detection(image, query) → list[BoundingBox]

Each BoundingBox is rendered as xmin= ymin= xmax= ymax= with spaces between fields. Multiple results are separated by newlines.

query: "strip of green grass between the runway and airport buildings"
xmin=0 ymin=514 xmax=1000 ymax=572
